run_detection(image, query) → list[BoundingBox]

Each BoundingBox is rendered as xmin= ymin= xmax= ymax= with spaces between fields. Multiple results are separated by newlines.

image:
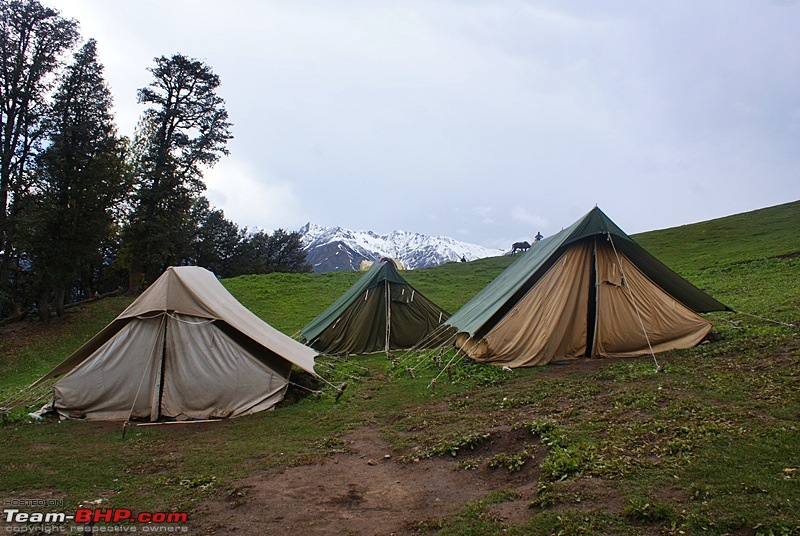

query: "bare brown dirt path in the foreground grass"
xmin=192 ymin=429 xmax=544 ymax=535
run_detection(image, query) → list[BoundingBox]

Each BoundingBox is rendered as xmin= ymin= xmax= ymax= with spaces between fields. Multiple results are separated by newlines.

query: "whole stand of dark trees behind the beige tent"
xmin=0 ymin=0 xmax=311 ymax=319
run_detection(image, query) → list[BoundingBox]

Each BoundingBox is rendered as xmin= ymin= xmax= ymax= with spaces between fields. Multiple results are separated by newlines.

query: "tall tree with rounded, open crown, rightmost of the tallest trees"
xmin=123 ymin=54 xmax=233 ymax=292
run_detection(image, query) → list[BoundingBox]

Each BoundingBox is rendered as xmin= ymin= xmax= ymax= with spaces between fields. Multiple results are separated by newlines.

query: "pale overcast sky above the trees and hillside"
xmin=50 ymin=0 xmax=800 ymax=249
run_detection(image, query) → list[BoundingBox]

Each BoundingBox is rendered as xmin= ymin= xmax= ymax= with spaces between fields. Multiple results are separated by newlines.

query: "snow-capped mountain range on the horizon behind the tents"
xmin=300 ymin=223 xmax=504 ymax=272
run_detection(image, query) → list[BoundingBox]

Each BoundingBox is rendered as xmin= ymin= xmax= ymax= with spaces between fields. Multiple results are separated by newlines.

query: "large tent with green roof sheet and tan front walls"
xmin=447 ymin=207 xmax=730 ymax=367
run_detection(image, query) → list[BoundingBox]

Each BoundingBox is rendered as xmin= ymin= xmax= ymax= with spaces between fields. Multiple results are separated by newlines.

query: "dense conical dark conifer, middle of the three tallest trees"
xmin=26 ymin=40 xmax=130 ymax=318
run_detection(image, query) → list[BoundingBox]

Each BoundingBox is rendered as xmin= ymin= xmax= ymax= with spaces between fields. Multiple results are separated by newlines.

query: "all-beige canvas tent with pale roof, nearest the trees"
xmin=37 ymin=266 xmax=317 ymax=421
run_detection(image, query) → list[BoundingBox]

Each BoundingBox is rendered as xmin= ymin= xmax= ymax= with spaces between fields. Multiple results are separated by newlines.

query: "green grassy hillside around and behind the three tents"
xmin=0 ymin=202 xmax=800 ymax=535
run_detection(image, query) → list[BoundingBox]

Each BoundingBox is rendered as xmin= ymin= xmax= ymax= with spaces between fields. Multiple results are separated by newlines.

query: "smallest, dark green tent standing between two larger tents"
xmin=301 ymin=259 xmax=450 ymax=355
